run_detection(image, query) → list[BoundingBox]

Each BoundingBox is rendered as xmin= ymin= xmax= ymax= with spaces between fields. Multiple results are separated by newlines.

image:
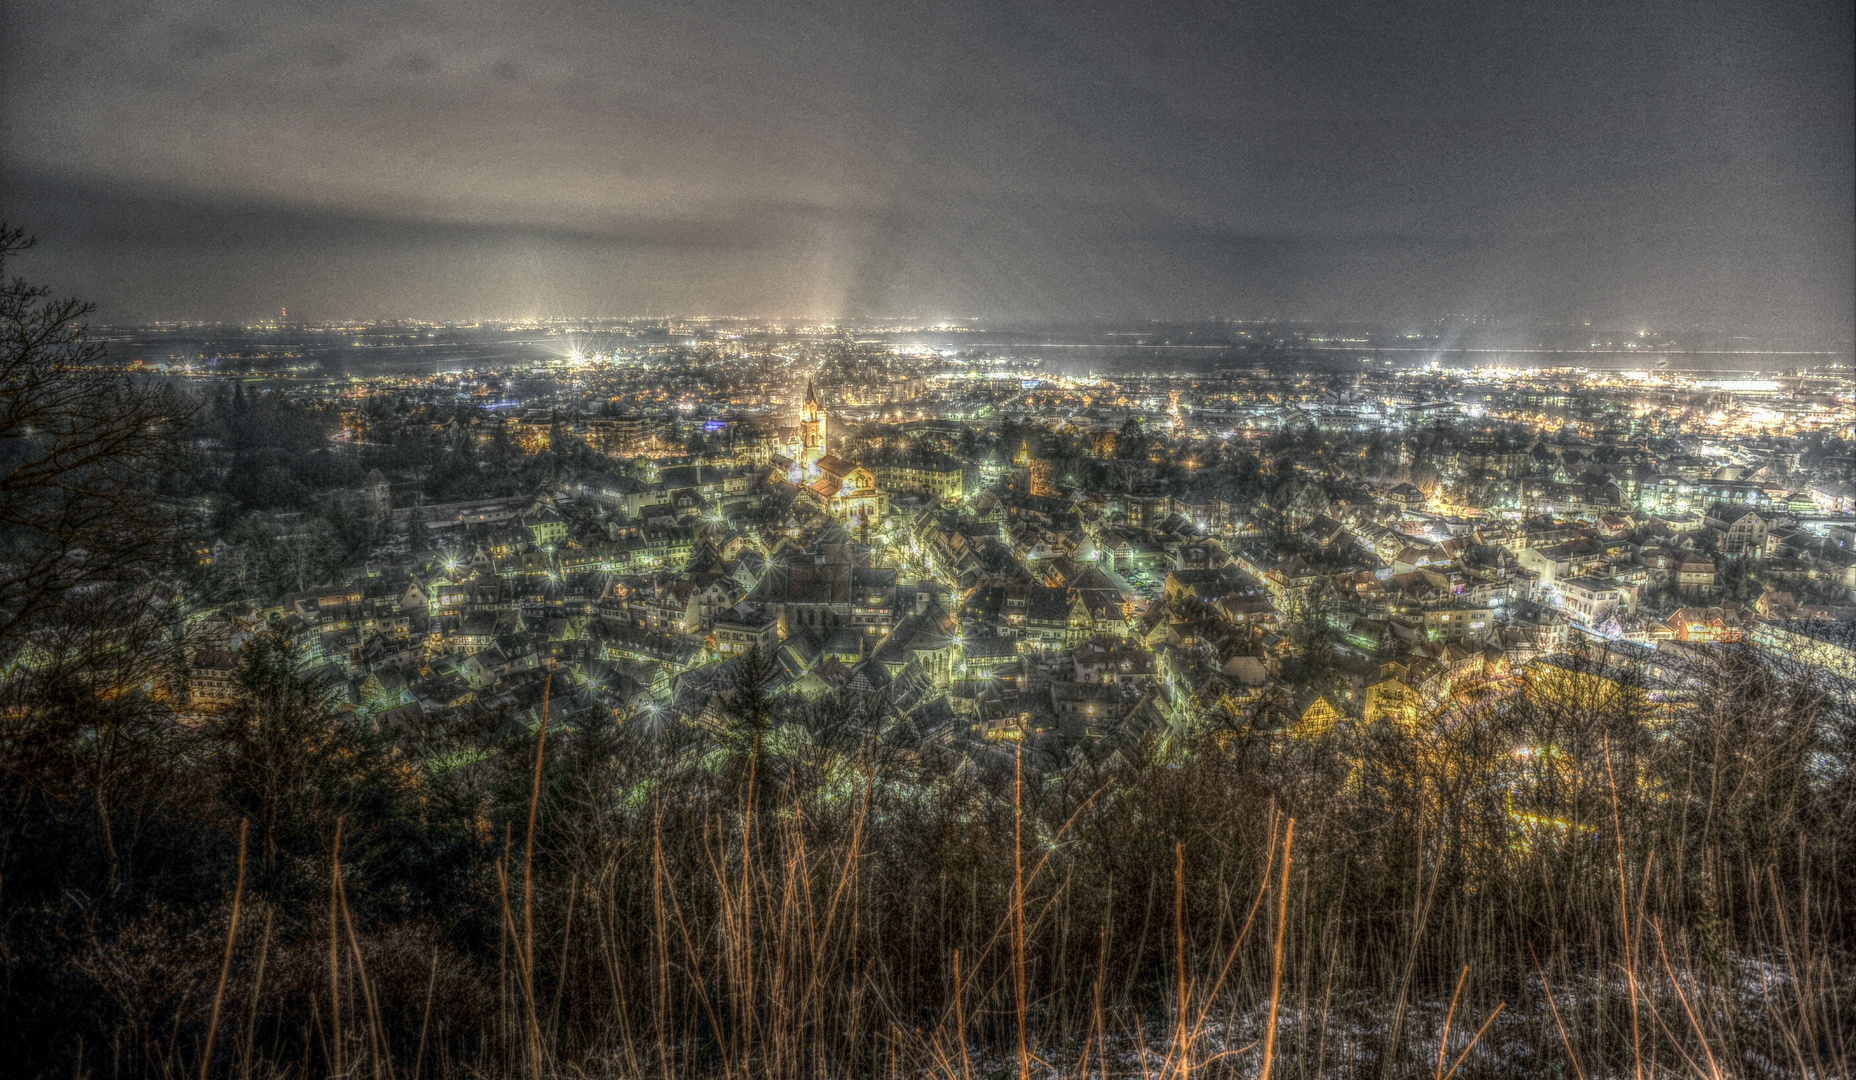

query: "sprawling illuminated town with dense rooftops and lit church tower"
xmin=152 ymin=325 xmax=1856 ymax=768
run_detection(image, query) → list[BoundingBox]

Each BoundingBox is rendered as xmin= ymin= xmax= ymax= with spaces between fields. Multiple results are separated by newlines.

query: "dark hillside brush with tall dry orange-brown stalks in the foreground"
xmin=0 ymin=642 xmax=1856 ymax=1078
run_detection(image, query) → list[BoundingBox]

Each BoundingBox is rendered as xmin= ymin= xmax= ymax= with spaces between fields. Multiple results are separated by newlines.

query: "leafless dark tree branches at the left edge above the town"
xmin=0 ymin=226 xmax=189 ymax=653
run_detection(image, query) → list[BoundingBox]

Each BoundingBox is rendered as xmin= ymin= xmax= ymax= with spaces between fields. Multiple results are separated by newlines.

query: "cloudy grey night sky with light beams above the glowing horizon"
xmin=0 ymin=0 xmax=1856 ymax=338
